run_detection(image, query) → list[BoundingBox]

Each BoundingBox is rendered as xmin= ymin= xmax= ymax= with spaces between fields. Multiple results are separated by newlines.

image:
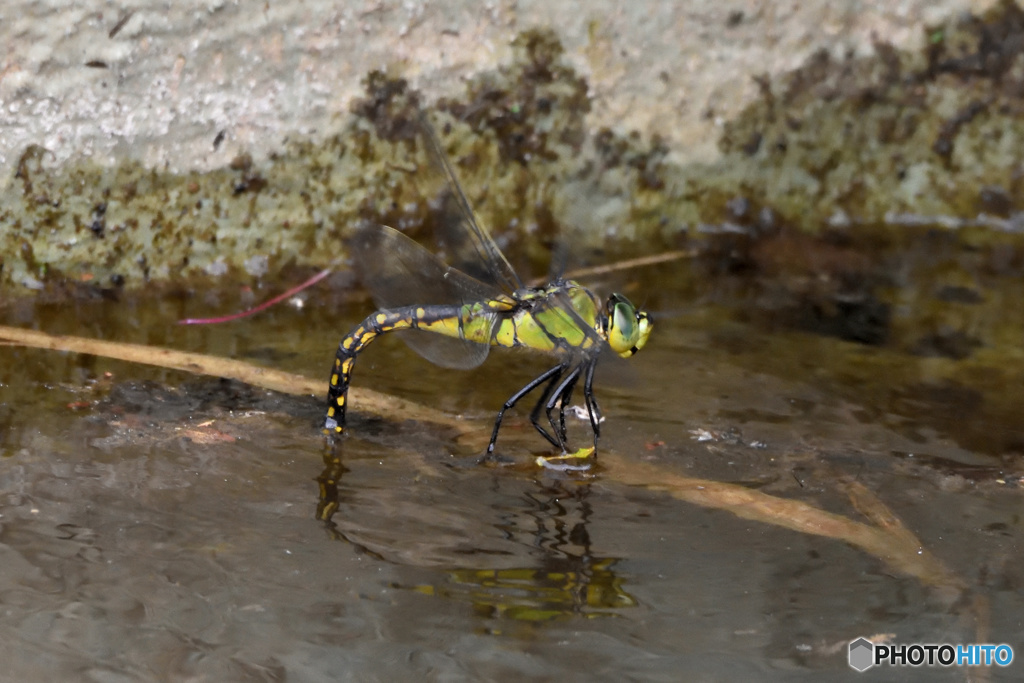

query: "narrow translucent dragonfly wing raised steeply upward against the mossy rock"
xmin=420 ymin=113 xmax=522 ymax=294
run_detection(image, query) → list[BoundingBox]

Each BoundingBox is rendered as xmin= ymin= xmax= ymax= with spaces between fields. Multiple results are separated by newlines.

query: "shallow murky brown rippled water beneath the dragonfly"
xmin=0 ymin=270 xmax=1024 ymax=681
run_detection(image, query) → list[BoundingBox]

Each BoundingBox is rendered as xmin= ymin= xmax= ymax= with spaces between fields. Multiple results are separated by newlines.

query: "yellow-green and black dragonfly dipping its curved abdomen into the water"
xmin=323 ymin=115 xmax=652 ymax=469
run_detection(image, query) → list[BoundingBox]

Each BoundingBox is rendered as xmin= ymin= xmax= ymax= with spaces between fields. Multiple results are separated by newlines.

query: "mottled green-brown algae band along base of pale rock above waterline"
xmin=6 ymin=1 xmax=1024 ymax=299
